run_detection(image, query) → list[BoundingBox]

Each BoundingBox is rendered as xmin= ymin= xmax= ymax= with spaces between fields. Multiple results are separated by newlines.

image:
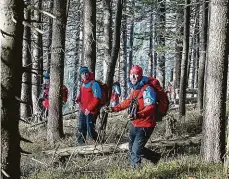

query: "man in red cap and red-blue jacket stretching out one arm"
xmin=107 ymin=65 xmax=156 ymax=168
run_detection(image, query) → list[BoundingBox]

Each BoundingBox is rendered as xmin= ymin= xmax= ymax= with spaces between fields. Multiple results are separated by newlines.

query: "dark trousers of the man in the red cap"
xmin=129 ymin=123 xmax=154 ymax=167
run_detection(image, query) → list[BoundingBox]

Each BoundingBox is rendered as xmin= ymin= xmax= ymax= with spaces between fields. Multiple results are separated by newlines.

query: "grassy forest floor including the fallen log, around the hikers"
xmin=20 ymin=102 xmax=229 ymax=179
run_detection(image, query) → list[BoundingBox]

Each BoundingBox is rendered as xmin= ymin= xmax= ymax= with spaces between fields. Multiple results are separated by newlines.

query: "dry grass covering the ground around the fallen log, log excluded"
xmin=20 ymin=105 xmax=229 ymax=179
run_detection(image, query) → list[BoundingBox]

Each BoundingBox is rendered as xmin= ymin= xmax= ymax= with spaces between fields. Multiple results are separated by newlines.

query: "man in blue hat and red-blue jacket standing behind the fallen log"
xmin=75 ymin=67 xmax=102 ymax=145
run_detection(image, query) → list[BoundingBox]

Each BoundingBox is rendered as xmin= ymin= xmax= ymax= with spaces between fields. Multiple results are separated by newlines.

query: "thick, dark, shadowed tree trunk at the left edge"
xmin=0 ymin=0 xmax=24 ymax=179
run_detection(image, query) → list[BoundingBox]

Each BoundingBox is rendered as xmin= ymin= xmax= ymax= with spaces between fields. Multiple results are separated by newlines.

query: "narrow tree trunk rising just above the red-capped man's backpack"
xmin=157 ymin=0 xmax=165 ymax=87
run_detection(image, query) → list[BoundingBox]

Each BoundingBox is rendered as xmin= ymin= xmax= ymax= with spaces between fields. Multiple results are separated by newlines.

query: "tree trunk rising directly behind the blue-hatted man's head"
xmin=83 ymin=0 xmax=96 ymax=72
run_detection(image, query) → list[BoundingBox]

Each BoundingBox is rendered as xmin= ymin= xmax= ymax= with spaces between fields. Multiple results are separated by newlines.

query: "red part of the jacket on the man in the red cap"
xmin=112 ymin=86 xmax=156 ymax=127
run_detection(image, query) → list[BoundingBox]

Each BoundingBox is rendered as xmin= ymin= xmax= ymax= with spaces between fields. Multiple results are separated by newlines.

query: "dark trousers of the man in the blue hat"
xmin=77 ymin=111 xmax=98 ymax=144
